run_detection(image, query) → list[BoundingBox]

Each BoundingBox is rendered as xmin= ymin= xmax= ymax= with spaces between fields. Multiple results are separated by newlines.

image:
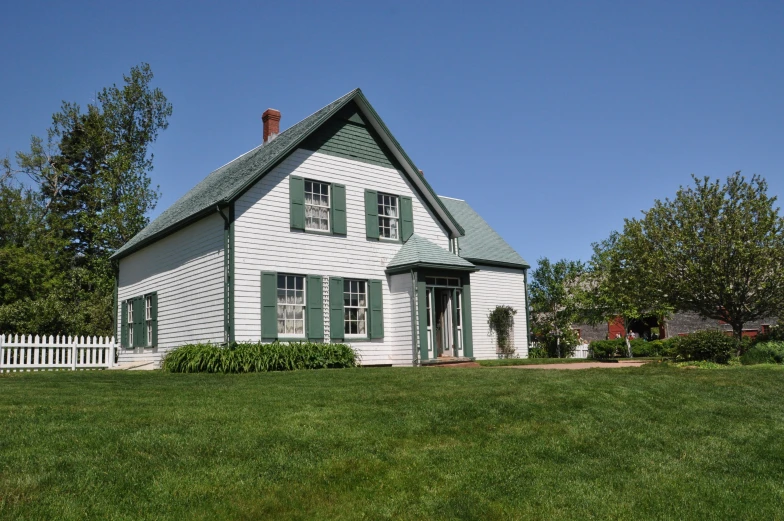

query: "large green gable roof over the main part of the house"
xmin=112 ymin=89 xmax=463 ymax=258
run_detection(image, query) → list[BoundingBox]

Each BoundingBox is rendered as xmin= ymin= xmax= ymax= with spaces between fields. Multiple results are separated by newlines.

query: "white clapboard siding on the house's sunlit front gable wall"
xmin=234 ymin=150 xmax=449 ymax=365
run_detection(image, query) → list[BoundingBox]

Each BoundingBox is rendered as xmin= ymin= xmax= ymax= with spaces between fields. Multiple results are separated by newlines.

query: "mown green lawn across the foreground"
xmin=0 ymin=364 xmax=784 ymax=520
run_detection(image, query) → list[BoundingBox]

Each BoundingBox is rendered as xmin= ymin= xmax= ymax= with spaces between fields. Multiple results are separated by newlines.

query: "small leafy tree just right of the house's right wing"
xmin=529 ymin=258 xmax=585 ymax=358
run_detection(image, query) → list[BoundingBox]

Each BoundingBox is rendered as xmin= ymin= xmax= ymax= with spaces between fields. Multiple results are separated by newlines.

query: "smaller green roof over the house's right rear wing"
xmin=441 ymin=196 xmax=531 ymax=268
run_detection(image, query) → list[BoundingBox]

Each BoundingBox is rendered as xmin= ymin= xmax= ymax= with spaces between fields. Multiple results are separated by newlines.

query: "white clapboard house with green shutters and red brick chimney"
xmin=114 ymin=89 xmax=529 ymax=365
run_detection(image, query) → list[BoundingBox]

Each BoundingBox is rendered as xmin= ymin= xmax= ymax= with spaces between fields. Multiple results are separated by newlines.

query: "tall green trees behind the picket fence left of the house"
xmin=0 ymin=64 xmax=172 ymax=335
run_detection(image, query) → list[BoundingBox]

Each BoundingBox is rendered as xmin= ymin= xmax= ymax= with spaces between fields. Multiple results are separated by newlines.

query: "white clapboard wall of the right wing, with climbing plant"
xmin=471 ymin=266 xmax=528 ymax=360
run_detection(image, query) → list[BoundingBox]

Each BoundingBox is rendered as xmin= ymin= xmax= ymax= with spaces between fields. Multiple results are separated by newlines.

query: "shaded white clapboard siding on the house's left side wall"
xmin=117 ymin=212 xmax=224 ymax=360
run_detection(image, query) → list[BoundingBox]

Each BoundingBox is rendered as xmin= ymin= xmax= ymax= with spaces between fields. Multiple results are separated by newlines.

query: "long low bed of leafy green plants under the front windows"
xmin=162 ymin=342 xmax=357 ymax=373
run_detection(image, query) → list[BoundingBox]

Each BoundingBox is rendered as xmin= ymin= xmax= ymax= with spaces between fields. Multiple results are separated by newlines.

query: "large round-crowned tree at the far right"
xmin=613 ymin=172 xmax=784 ymax=339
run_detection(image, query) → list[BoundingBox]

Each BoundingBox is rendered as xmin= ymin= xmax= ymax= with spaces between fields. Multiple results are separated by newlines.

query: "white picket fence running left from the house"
xmin=0 ymin=335 xmax=116 ymax=373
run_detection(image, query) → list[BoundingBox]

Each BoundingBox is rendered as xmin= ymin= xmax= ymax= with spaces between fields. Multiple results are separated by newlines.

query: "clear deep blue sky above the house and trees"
xmin=0 ymin=0 xmax=784 ymax=263
